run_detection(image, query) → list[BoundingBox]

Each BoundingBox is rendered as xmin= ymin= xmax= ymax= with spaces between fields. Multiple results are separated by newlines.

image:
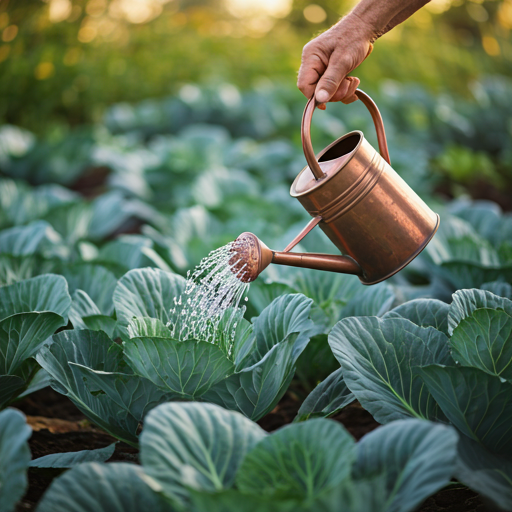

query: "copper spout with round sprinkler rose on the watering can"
xmin=230 ymin=233 xmax=362 ymax=283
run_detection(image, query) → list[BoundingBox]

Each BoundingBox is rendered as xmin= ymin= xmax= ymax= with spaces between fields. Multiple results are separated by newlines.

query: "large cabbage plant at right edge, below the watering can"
xmin=324 ymin=283 xmax=512 ymax=510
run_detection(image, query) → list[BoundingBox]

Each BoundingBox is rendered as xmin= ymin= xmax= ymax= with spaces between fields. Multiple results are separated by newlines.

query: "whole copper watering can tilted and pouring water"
xmin=232 ymin=89 xmax=439 ymax=285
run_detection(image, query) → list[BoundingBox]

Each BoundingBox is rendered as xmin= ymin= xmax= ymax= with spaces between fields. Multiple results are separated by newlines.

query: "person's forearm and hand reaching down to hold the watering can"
xmin=297 ymin=0 xmax=429 ymax=103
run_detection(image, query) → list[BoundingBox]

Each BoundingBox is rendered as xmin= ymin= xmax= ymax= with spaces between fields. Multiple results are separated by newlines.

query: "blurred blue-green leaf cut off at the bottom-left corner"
xmin=0 ymin=409 xmax=32 ymax=512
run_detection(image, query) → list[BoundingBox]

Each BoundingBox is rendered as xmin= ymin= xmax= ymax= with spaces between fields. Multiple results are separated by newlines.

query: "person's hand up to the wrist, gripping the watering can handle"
xmin=297 ymin=13 xmax=375 ymax=108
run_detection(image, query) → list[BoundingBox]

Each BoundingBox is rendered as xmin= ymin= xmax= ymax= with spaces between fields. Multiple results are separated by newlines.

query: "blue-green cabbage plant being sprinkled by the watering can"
xmin=37 ymin=269 xmax=313 ymax=444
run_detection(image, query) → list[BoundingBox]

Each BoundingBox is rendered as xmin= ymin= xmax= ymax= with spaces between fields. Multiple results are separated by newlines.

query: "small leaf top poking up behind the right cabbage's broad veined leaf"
xmin=382 ymin=299 xmax=450 ymax=334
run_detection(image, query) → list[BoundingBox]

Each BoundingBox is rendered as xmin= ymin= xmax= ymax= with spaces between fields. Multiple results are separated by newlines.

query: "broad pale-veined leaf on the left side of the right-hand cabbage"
xmin=329 ymin=317 xmax=453 ymax=423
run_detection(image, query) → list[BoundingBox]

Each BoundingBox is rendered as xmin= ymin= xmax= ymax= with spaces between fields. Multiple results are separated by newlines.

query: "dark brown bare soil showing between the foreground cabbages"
xmin=15 ymin=388 xmax=496 ymax=512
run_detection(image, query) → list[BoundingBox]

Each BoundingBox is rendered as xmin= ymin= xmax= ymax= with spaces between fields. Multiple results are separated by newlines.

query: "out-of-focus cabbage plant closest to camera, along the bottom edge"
xmin=37 ymin=402 xmax=457 ymax=512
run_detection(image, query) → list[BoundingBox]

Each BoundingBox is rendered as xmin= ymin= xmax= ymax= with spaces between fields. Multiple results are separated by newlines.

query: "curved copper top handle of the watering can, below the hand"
xmin=301 ymin=89 xmax=391 ymax=180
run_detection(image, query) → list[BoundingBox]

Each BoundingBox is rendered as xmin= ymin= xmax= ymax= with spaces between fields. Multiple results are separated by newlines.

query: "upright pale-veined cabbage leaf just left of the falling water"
xmin=114 ymin=268 xmax=186 ymax=339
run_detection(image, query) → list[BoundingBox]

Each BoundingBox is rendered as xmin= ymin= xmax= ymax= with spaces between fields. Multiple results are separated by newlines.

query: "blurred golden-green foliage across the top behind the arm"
xmin=0 ymin=0 xmax=512 ymax=132
